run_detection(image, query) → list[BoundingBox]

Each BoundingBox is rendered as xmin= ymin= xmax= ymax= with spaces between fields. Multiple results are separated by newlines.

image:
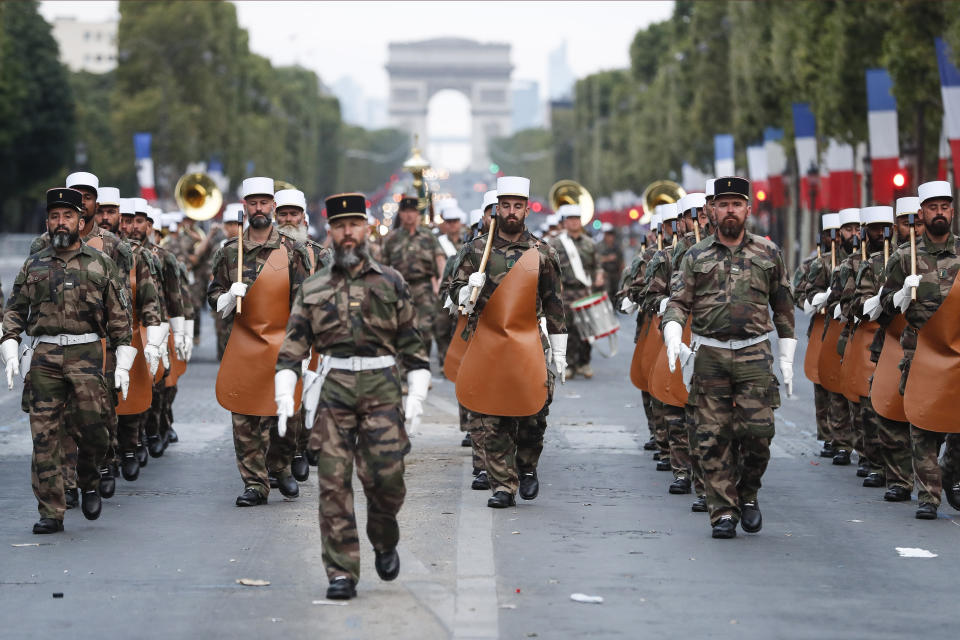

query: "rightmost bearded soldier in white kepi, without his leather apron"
xmin=880 ymin=181 xmax=960 ymax=520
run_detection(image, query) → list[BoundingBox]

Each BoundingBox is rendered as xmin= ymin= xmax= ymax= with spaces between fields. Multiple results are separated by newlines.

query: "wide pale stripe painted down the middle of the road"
xmin=453 ymin=458 xmax=500 ymax=639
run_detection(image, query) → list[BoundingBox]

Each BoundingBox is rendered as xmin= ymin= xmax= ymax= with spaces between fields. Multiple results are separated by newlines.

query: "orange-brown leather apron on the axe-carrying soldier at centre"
xmin=456 ymin=247 xmax=547 ymax=416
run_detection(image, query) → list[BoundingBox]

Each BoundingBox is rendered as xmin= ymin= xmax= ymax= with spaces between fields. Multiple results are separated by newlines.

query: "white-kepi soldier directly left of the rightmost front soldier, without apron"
xmin=857 ymin=196 xmax=923 ymax=502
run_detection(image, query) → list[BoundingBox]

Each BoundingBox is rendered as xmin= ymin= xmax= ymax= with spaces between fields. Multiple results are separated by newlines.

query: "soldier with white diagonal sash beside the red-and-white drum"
xmin=550 ymin=204 xmax=603 ymax=379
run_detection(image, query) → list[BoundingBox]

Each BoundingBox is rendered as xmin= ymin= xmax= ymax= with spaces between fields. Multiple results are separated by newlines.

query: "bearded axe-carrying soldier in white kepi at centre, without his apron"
xmin=450 ymin=177 xmax=567 ymax=509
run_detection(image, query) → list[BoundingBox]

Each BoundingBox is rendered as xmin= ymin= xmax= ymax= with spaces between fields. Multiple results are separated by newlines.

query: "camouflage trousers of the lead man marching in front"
xmin=310 ymin=367 xmax=410 ymax=580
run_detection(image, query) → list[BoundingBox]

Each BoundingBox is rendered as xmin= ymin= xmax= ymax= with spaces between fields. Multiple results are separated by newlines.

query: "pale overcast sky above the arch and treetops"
xmin=41 ymin=0 xmax=673 ymax=97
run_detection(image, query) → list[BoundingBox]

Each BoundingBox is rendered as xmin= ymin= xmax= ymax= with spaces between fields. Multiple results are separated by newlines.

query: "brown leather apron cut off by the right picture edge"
xmin=903 ymin=277 xmax=960 ymax=433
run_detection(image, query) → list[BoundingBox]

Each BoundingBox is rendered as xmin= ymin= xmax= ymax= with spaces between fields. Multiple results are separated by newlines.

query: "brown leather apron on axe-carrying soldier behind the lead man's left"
xmin=216 ymin=243 xmax=302 ymax=416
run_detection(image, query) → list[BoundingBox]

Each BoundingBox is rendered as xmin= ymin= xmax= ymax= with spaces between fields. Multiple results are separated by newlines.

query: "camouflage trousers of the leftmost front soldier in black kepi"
xmin=23 ymin=343 xmax=111 ymax=520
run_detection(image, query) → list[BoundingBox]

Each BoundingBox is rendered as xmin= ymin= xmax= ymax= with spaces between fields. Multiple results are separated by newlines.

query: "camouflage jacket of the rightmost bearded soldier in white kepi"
xmin=880 ymin=233 xmax=960 ymax=363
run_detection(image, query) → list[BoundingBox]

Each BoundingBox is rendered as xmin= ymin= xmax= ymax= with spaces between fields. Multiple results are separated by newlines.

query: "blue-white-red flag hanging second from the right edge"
xmin=867 ymin=69 xmax=900 ymax=204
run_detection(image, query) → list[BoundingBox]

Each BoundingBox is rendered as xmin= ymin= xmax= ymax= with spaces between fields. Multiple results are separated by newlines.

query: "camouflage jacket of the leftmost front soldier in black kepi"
xmin=2 ymin=243 xmax=132 ymax=349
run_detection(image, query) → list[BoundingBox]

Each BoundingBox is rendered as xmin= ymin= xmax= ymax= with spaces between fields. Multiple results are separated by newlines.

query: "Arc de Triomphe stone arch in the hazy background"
xmin=386 ymin=38 xmax=513 ymax=171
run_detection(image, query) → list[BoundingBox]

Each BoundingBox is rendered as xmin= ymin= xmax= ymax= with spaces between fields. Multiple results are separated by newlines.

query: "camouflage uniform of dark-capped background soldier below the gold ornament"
xmin=383 ymin=227 xmax=444 ymax=353
